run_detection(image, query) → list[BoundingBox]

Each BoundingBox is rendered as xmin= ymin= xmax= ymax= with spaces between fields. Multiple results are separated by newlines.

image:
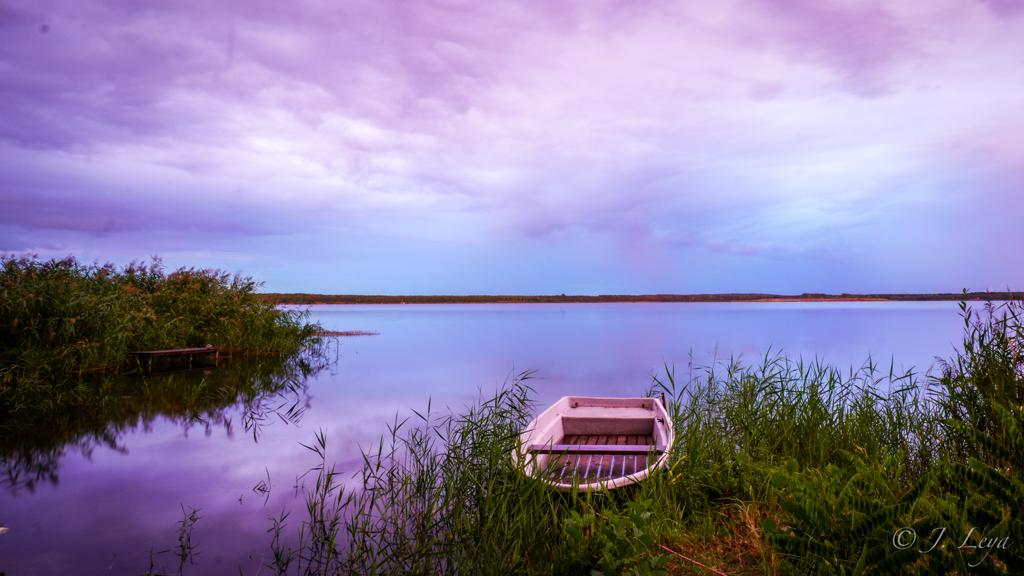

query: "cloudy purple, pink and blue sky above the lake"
xmin=0 ymin=0 xmax=1024 ymax=294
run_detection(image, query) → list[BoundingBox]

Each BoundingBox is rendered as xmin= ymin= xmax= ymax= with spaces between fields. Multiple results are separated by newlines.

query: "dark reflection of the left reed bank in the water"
xmin=0 ymin=349 xmax=329 ymax=495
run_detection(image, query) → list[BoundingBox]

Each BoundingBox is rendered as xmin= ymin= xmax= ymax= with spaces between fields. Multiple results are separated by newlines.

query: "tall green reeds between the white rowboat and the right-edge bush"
xmin=652 ymin=355 xmax=936 ymax=508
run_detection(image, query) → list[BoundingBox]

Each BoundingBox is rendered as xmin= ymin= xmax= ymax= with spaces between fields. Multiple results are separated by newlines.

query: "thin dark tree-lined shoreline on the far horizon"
xmin=259 ymin=292 xmax=1024 ymax=304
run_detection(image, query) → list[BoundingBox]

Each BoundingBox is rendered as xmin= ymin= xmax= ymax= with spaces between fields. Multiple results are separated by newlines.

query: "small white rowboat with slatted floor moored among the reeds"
xmin=516 ymin=396 xmax=675 ymax=492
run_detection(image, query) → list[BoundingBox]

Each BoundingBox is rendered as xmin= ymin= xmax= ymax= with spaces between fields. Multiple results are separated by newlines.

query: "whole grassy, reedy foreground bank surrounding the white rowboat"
xmin=234 ymin=297 xmax=1024 ymax=575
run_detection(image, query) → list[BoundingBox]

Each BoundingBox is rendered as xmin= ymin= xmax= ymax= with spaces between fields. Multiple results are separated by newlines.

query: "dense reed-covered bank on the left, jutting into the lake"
xmin=0 ymin=256 xmax=317 ymax=422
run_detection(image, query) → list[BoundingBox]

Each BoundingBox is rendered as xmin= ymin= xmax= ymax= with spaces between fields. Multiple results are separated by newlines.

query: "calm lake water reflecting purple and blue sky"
xmin=0 ymin=302 xmax=963 ymax=575
